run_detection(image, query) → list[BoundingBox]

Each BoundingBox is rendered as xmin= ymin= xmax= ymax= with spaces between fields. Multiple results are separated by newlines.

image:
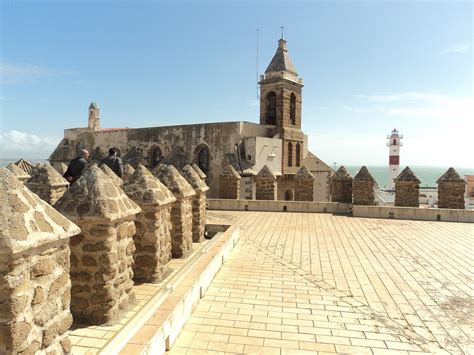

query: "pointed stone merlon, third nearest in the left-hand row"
xmin=123 ymin=164 xmax=176 ymax=282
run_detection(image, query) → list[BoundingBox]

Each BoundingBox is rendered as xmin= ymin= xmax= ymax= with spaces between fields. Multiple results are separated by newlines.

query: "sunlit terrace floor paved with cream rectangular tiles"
xmin=170 ymin=211 xmax=474 ymax=354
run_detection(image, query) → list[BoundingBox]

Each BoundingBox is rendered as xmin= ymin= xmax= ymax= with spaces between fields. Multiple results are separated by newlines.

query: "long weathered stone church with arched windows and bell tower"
xmin=49 ymin=38 xmax=334 ymax=201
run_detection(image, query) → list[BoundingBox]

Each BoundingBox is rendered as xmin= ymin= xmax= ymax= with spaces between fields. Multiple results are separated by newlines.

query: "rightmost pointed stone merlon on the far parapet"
xmin=436 ymin=168 xmax=466 ymax=210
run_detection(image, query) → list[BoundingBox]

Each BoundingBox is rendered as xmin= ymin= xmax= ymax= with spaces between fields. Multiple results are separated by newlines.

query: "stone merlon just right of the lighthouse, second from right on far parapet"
xmin=394 ymin=166 xmax=420 ymax=207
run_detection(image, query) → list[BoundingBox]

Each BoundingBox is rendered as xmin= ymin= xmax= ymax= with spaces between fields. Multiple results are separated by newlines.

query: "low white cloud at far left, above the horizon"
xmin=0 ymin=130 xmax=60 ymax=157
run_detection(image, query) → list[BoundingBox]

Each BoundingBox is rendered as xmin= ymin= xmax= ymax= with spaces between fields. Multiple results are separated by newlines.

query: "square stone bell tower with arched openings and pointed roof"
xmin=259 ymin=38 xmax=304 ymax=174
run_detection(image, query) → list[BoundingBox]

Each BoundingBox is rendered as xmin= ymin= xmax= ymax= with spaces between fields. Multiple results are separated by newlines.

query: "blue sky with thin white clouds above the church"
xmin=0 ymin=0 xmax=474 ymax=168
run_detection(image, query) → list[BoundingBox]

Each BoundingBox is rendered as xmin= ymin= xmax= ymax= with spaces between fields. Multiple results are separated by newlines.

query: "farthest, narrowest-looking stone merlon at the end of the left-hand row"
xmin=181 ymin=165 xmax=209 ymax=243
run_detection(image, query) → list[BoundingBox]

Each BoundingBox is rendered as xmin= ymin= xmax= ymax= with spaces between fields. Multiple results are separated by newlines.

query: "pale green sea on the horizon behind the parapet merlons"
xmin=0 ymin=159 xmax=474 ymax=189
